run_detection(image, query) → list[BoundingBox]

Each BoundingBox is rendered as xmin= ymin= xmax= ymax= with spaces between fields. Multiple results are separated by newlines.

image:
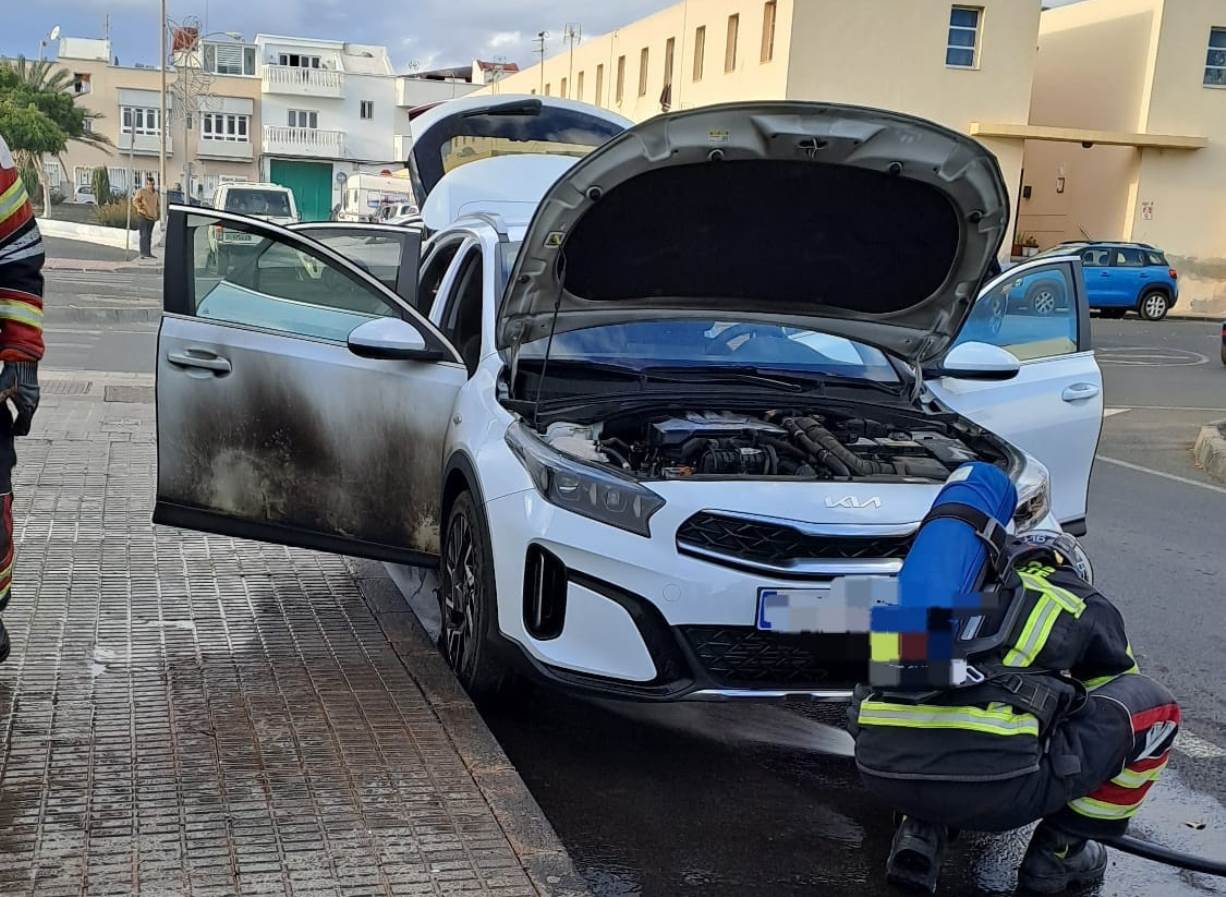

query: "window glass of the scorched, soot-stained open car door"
xmin=188 ymin=216 xmax=401 ymax=342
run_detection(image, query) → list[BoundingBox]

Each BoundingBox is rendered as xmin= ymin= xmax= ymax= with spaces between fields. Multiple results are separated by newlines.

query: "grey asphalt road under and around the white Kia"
xmin=47 ymin=240 xmax=1226 ymax=897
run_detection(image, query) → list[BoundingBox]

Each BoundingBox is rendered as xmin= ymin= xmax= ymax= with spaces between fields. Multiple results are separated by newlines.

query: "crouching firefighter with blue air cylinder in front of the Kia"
xmin=851 ymin=463 xmax=1179 ymax=893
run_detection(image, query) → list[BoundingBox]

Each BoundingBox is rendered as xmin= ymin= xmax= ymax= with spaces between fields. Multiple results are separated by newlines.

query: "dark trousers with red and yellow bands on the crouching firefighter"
xmin=861 ymin=673 xmax=1179 ymax=838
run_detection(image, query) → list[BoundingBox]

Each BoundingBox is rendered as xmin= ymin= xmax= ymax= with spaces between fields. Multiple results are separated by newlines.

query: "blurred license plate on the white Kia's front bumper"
xmin=758 ymin=576 xmax=897 ymax=635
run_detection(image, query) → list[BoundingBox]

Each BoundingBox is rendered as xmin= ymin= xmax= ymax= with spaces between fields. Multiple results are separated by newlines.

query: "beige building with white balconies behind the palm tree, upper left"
xmin=47 ymin=38 xmax=260 ymax=196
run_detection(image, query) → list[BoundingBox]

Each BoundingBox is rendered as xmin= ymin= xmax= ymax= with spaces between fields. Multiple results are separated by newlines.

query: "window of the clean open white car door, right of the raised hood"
xmin=958 ymin=265 xmax=1079 ymax=361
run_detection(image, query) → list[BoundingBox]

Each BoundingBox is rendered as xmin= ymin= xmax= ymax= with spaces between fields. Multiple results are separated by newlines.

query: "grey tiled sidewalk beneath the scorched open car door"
xmin=0 ymin=380 xmax=581 ymax=897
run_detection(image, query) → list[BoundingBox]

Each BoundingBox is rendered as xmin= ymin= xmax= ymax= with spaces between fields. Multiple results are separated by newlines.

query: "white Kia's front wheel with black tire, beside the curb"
xmin=439 ymin=493 xmax=510 ymax=697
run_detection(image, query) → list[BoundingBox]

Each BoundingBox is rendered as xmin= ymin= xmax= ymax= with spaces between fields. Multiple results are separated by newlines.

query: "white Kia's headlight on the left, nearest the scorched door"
xmin=506 ymin=423 xmax=664 ymax=537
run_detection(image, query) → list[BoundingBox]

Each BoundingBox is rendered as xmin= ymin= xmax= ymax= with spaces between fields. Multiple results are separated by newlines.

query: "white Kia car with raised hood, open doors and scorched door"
xmin=154 ymin=97 xmax=1102 ymax=701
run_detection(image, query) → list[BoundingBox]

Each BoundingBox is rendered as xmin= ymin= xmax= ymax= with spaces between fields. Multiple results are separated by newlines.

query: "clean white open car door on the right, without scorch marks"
xmin=929 ymin=257 xmax=1102 ymax=534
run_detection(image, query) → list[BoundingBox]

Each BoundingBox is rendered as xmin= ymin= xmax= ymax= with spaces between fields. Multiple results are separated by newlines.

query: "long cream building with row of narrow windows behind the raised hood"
xmin=484 ymin=0 xmax=1041 ymax=251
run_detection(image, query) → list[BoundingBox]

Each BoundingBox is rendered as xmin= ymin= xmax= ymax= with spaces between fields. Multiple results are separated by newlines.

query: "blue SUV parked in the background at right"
xmin=1041 ymin=240 xmax=1179 ymax=321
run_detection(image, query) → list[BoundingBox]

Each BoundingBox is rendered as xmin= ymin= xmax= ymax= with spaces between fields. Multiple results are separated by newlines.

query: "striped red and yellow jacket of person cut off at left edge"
xmin=0 ymin=138 xmax=43 ymax=361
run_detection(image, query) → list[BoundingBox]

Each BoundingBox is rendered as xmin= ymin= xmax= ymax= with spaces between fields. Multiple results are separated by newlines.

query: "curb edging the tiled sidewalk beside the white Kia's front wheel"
xmin=349 ymin=559 xmax=591 ymax=897
